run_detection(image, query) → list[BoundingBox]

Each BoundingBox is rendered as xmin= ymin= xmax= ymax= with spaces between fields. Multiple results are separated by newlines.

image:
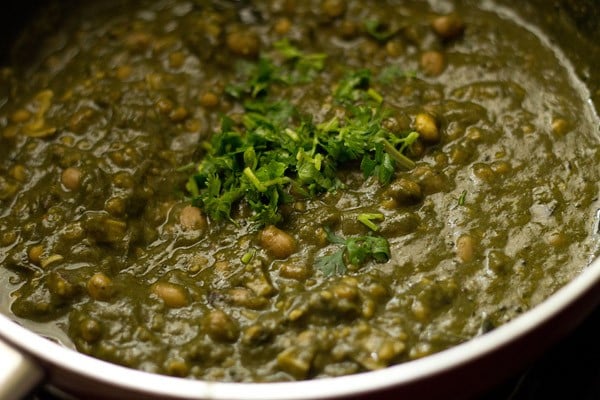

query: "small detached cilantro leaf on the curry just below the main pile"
xmin=315 ymin=227 xmax=390 ymax=276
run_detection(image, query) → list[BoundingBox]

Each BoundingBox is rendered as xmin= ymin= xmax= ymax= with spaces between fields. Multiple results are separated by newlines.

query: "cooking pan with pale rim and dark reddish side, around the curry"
xmin=0 ymin=0 xmax=600 ymax=400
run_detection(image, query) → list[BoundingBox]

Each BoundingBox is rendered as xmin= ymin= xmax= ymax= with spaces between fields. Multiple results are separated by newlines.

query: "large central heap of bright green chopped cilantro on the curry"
xmin=187 ymin=40 xmax=418 ymax=226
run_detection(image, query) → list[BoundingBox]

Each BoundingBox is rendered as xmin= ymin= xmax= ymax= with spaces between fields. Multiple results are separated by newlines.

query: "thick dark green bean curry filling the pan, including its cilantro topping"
xmin=0 ymin=0 xmax=600 ymax=382
